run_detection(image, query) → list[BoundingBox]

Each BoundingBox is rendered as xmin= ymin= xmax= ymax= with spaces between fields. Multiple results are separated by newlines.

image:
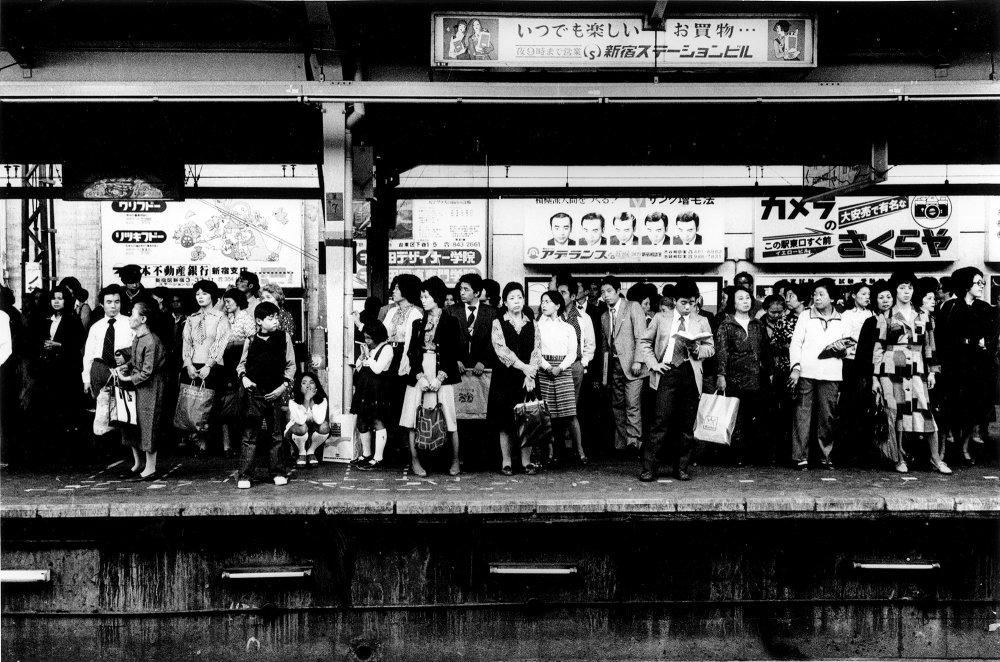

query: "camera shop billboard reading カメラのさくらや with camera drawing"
xmin=754 ymin=195 xmax=980 ymax=265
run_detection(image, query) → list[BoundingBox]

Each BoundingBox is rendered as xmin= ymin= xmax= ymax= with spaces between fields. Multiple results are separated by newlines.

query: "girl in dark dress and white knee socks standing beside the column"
xmin=351 ymin=320 xmax=392 ymax=471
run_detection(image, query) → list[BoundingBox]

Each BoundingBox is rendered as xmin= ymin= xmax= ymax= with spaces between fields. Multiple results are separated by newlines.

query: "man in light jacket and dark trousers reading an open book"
xmin=639 ymin=278 xmax=715 ymax=482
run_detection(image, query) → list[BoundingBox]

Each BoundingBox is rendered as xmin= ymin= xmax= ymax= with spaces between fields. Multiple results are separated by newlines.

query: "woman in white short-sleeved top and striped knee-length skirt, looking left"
xmin=540 ymin=290 xmax=587 ymax=474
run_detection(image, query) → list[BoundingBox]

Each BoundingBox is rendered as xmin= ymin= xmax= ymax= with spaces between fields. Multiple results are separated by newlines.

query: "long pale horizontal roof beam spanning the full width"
xmin=0 ymin=80 xmax=1000 ymax=104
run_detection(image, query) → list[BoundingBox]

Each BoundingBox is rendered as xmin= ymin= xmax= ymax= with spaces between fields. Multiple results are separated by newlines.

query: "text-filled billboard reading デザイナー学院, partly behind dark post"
xmin=354 ymin=199 xmax=486 ymax=290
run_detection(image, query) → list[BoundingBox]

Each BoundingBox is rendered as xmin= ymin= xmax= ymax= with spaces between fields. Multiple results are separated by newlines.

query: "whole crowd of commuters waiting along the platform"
xmin=0 ymin=265 xmax=1000 ymax=488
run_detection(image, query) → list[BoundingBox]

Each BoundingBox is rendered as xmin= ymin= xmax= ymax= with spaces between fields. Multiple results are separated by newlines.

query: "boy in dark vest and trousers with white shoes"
xmin=236 ymin=301 xmax=295 ymax=490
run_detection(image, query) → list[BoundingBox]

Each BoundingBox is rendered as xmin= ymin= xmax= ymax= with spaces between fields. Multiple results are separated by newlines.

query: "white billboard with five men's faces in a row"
xmin=512 ymin=196 xmax=732 ymax=265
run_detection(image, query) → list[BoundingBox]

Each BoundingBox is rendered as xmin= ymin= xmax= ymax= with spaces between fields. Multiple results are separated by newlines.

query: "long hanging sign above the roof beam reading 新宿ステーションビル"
xmin=431 ymin=11 xmax=816 ymax=69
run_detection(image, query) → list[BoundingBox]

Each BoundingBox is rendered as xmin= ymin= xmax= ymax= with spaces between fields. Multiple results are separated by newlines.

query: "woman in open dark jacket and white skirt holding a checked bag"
xmin=399 ymin=276 xmax=461 ymax=477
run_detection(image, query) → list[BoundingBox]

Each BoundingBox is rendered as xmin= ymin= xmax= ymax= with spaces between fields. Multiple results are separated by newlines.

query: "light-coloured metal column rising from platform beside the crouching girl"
xmin=321 ymin=103 xmax=354 ymax=411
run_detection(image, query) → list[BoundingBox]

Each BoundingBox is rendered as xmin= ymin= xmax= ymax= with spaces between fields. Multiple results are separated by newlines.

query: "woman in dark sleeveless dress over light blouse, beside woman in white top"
xmin=486 ymin=283 xmax=542 ymax=476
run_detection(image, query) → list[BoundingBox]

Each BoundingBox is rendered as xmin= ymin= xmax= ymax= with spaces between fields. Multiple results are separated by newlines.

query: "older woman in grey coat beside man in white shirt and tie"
xmin=116 ymin=301 xmax=167 ymax=481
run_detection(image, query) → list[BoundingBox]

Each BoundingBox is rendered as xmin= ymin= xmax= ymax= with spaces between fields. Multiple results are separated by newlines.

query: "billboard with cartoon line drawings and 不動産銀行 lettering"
xmin=101 ymin=199 xmax=303 ymax=287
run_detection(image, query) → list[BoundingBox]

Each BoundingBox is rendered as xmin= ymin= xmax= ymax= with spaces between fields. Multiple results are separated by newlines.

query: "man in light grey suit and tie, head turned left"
xmin=601 ymin=274 xmax=646 ymax=452
